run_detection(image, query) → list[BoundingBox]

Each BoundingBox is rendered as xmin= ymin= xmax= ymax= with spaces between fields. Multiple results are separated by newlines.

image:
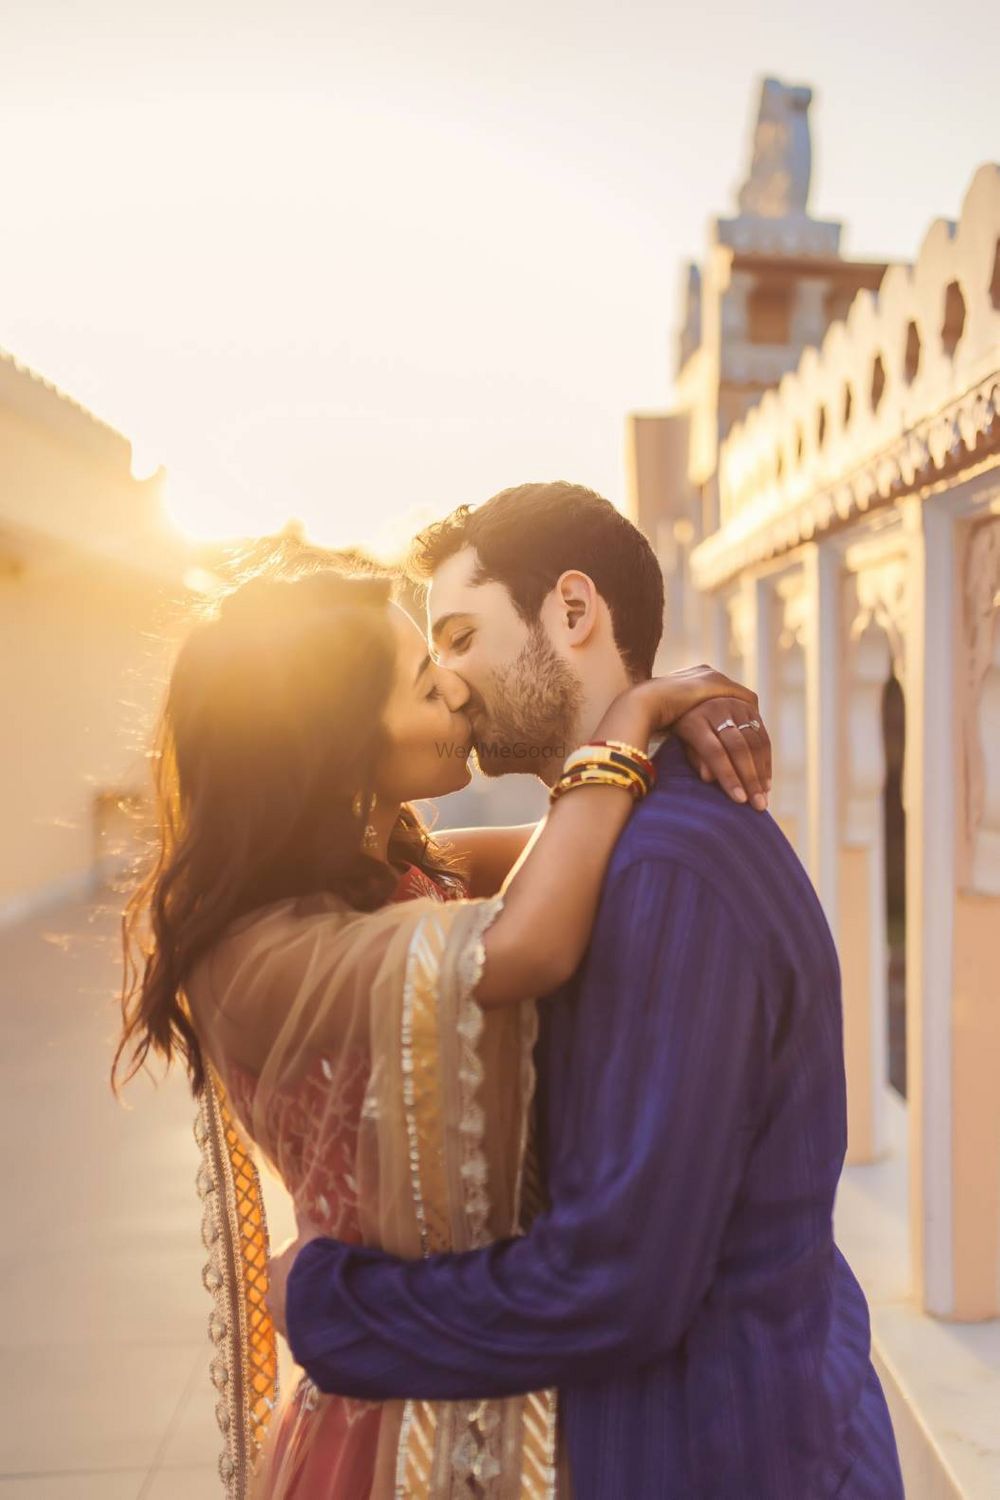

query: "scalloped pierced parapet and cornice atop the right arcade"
xmin=691 ymin=165 xmax=1000 ymax=590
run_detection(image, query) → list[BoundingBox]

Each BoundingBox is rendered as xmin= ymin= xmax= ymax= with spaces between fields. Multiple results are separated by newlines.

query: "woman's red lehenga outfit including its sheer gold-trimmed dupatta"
xmin=189 ymin=867 xmax=556 ymax=1500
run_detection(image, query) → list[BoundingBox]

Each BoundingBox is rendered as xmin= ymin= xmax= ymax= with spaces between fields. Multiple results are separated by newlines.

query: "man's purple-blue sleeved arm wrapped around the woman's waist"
xmin=286 ymin=861 xmax=765 ymax=1400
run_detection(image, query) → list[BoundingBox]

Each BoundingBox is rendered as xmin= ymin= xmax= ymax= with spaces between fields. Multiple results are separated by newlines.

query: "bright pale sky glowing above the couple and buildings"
xmin=0 ymin=0 xmax=1000 ymax=552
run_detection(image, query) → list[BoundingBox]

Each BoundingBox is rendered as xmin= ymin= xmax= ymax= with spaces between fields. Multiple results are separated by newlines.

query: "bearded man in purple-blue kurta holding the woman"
xmin=274 ymin=485 xmax=903 ymax=1500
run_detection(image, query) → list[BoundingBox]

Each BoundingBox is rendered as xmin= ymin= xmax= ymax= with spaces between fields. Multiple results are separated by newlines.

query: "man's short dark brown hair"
xmin=408 ymin=480 xmax=663 ymax=681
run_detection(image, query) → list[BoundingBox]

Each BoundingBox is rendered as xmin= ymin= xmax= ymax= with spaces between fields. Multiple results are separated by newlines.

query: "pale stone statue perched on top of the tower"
xmin=739 ymin=78 xmax=813 ymax=219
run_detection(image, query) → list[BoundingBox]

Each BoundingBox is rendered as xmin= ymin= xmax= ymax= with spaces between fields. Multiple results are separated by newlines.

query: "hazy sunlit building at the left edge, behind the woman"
xmin=0 ymin=354 xmax=190 ymax=923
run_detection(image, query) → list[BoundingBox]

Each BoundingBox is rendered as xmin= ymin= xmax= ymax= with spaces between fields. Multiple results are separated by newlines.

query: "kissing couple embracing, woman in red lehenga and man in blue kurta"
xmin=117 ymin=483 xmax=903 ymax=1500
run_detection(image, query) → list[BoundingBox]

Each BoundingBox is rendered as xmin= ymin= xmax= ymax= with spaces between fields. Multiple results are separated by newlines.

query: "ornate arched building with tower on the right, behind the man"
xmin=631 ymin=83 xmax=1000 ymax=1496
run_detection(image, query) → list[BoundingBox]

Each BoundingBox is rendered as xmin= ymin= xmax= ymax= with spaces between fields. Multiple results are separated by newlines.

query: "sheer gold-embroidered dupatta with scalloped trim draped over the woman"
xmin=189 ymin=896 xmax=556 ymax=1500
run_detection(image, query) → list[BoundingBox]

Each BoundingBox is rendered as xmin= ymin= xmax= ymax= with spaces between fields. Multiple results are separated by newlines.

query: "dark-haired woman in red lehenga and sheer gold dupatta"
xmin=115 ymin=569 xmax=753 ymax=1500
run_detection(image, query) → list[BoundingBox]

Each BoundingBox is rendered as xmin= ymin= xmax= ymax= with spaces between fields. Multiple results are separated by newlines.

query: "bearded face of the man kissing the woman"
xmin=427 ymin=548 xmax=583 ymax=780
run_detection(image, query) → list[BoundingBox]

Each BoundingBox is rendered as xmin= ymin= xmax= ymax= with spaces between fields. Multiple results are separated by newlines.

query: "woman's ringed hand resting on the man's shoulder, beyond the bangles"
xmin=595 ymin=666 xmax=771 ymax=812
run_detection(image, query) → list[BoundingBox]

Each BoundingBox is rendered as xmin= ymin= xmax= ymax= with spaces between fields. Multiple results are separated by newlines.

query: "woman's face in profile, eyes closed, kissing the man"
xmin=375 ymin=605 xmax=472 ymax=804
